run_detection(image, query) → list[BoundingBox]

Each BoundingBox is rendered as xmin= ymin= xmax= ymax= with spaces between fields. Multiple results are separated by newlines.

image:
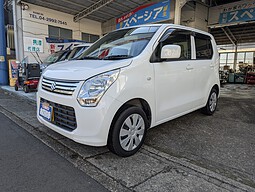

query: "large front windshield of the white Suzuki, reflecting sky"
xmin=78 ymin=26 xmax=159 ymax=60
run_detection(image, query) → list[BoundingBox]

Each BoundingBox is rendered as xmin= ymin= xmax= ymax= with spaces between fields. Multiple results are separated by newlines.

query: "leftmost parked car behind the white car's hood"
xmin=40 ymin=50 xmax=71 ymax=71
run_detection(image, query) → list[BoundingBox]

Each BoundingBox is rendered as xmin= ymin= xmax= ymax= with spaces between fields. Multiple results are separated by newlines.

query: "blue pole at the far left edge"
xmin=0 ymin=0 xmax=8 ymax=85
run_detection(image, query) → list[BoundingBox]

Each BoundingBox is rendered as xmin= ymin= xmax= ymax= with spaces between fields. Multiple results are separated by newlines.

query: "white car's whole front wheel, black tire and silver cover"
xmin=107 ymin=106 xmax=149 ymax=157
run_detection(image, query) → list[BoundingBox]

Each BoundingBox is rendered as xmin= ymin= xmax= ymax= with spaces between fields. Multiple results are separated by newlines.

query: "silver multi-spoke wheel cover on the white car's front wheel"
xmin=119 ymin=114 xmax=145 ymax=151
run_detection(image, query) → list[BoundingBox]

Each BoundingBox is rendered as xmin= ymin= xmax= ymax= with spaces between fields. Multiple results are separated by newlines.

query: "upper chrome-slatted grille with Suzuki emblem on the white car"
xmin=42 ymin=78 xmax=79 ymax=95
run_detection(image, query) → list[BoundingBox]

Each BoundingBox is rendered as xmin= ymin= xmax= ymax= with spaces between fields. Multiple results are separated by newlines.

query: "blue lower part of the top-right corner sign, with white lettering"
xmin=219 ymin=8 xmax=255 ymax=24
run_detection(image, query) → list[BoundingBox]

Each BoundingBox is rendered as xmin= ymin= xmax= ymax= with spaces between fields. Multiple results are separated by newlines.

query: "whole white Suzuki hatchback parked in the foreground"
xmin=37 ymin=24 xmax=220 ymax=157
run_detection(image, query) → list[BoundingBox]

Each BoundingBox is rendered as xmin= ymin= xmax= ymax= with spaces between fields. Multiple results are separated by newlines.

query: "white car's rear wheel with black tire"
xmin=202 ymin=88 xmax=218 ymax=115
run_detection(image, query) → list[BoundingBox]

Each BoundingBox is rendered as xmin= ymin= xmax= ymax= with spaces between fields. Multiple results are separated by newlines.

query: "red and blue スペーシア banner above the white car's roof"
xmin=116 ymin=0 xmax=170 ymax=29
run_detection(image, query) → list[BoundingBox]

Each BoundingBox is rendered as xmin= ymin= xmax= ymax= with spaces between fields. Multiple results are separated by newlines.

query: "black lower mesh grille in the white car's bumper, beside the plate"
xmin=41 ymin=98 xmax=77 ymax=131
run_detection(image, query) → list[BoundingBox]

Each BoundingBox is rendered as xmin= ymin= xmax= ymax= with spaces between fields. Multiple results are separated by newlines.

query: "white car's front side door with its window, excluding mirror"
xmin=151 ymin=29 xmax=195 ymax=123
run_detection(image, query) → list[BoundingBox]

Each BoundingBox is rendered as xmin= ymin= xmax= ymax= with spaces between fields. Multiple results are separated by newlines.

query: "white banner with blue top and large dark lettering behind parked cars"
xmin=46 ymin=37 xmax=87 ymax=53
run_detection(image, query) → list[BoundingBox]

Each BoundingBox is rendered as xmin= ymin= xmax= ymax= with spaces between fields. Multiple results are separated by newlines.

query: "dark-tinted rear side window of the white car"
xmin=195 ymin=34 xmax=213 ymax=59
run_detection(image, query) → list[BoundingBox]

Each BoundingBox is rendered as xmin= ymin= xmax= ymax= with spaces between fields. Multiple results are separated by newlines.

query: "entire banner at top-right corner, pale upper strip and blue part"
xmin=219 ymin=1 xmax=255 ymax=24
